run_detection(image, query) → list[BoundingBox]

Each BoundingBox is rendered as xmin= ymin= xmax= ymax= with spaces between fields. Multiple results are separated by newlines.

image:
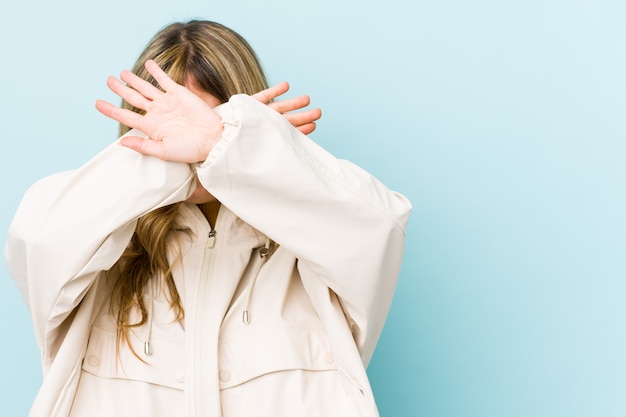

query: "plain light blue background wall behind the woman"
xmin=0 ymin=0 xmax=626 ymax=417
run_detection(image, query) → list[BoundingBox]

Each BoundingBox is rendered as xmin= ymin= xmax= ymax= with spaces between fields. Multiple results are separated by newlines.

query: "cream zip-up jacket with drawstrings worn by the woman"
xmin=5 ymin=95 xmax=411 ymax=417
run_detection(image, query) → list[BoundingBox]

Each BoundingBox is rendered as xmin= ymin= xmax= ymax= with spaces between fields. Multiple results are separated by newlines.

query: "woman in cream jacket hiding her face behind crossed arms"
xmin=5 ymin=21 xmax=410 ymax=417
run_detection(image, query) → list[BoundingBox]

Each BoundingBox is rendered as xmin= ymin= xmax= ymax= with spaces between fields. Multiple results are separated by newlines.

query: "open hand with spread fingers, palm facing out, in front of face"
xmin=96 ymin=60 xmax=223 ymax=163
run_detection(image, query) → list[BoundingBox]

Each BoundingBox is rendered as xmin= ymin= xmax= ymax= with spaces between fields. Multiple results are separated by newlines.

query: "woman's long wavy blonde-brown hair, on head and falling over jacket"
xmin=109 ymin=20 xmax=268 ymax=357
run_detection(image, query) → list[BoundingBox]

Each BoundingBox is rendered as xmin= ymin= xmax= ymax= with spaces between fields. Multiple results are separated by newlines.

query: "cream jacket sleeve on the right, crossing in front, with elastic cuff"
xmin=197 ymin=95 xmax=411 ymax=363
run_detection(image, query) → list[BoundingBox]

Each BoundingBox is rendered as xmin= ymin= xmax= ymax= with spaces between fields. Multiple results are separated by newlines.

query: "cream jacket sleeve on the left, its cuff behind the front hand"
xmin=5 ymin=132 xmax=194 ymax=363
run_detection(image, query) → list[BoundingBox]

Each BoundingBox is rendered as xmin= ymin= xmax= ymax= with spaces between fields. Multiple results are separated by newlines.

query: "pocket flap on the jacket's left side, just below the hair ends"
xmin=83 ymin=326 xmax=185 ymax=390
